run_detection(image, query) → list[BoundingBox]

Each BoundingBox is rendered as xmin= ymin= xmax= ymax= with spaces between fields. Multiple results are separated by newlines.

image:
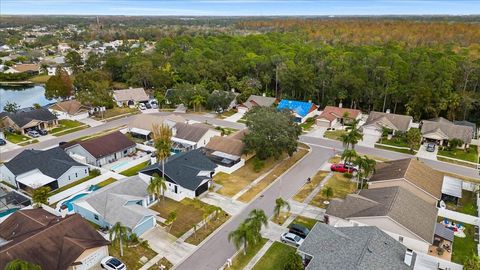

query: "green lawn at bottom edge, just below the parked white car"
xmin=253 ymin=242 xmax=296 ymax=270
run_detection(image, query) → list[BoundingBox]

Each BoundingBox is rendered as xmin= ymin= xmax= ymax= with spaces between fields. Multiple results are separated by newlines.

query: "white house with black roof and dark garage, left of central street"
xmin=139 ymin=149 xmax=217 ymax=201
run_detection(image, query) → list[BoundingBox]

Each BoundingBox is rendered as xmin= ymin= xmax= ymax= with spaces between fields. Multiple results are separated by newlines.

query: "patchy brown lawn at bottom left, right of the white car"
xmin=108 ymin=242 xmax=157 ymax=269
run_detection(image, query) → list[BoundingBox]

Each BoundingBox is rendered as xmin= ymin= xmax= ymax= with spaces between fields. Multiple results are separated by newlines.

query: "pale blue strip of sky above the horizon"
xmin=0 ymin=0 xmax=480 ymax=16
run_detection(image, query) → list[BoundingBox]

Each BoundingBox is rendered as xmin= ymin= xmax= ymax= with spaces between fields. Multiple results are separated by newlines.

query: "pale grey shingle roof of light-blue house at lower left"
xmin=74 ymin=176 xmax=157 ymax=229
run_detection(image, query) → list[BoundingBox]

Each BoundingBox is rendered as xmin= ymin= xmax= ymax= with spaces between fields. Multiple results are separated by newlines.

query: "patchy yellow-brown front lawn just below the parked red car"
xmin=310 ymin=173 xmax=357 ymax=208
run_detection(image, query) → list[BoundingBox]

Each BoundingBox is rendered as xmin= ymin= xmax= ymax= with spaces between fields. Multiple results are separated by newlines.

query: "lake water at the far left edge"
xmin=0 ymin=85 xmax=55 ymax=111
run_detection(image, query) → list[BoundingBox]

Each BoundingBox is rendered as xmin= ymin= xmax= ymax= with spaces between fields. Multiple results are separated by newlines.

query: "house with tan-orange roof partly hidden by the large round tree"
xmin=204 ymin=131 xmax=245 ymax=173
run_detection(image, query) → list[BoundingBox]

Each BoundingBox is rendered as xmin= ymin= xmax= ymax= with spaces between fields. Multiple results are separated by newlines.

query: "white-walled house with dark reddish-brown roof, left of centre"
xmin=61 ymin=131 xmax=136 ymax=167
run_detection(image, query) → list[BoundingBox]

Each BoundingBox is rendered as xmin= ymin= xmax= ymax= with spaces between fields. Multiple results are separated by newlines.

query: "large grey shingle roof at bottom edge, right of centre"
xmin=298 ymin=222 xmax=416 ymax=270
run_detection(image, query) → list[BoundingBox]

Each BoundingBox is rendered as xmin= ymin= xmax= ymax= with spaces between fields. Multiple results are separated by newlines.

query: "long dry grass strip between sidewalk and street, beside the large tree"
xmin=238 ymin=149 xmax=308 ymax=202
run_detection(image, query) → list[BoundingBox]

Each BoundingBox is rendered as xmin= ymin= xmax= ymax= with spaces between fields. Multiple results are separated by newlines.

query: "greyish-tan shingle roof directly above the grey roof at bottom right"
xmin=326 ymin=187 xmax=438 ymax=243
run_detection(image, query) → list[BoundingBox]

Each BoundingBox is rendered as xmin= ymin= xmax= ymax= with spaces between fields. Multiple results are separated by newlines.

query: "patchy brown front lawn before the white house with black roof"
xmin=150 ymin=197 xmax=218 ymax=238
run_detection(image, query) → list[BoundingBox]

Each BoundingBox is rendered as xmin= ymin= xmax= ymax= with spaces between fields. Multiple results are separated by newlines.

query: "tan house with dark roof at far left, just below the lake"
xmin=0 ymin=108 xmax=58 ymax=134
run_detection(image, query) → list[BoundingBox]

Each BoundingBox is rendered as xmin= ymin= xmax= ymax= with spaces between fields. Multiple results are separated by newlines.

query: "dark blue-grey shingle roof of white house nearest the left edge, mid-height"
xmin=4 ymin=147 xmax=87 ymax=179
